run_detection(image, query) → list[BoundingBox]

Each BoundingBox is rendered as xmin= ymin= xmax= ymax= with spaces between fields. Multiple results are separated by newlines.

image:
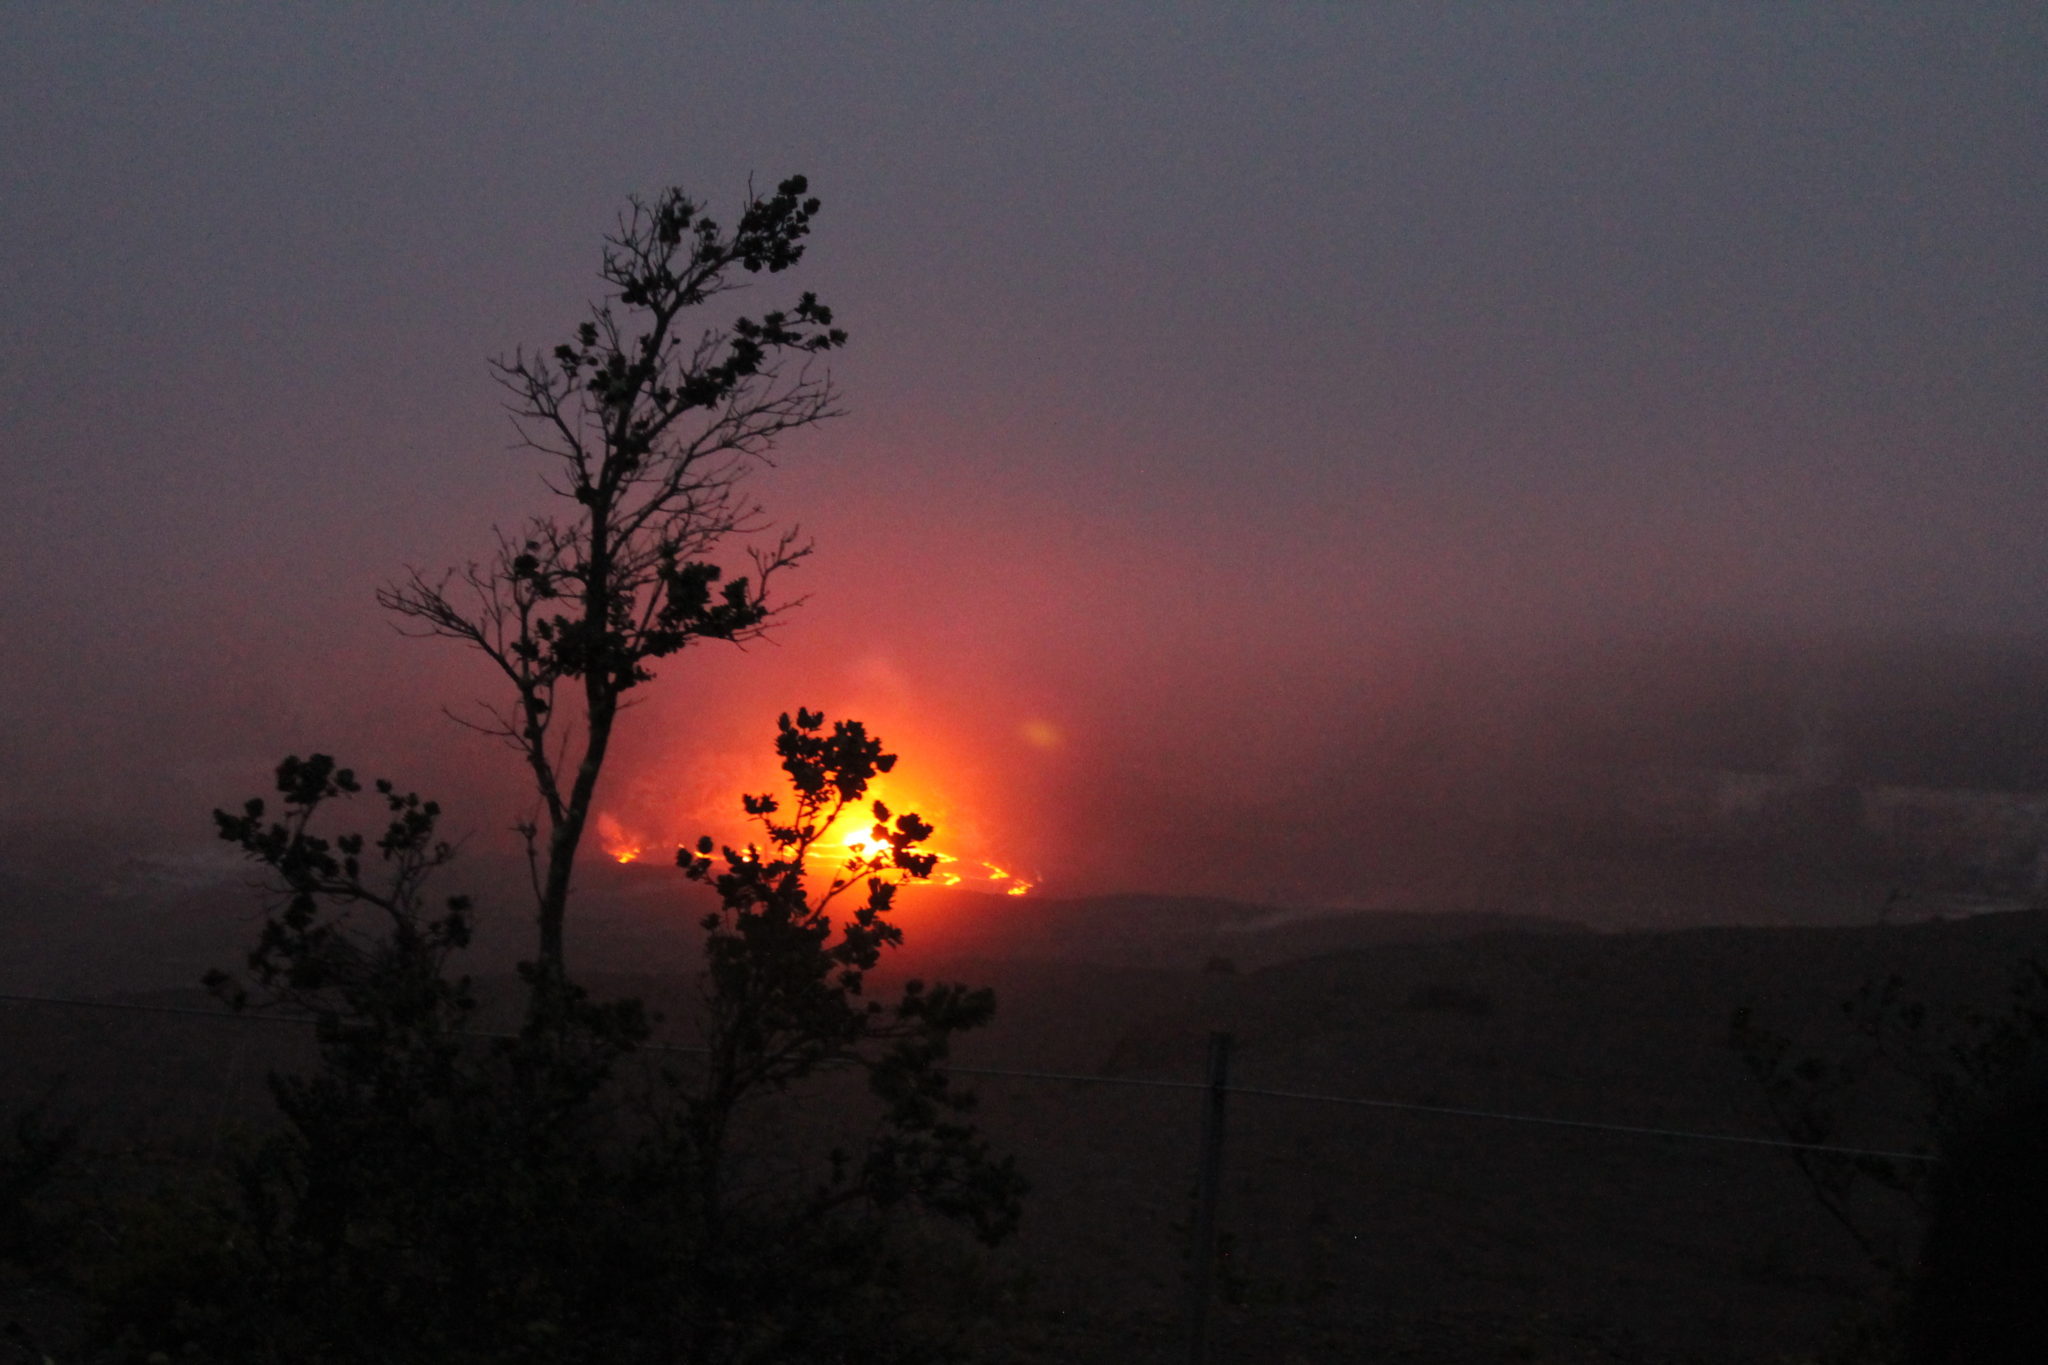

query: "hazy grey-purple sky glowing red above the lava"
xmin=0 ymin=4 xmax=2048 ymax=900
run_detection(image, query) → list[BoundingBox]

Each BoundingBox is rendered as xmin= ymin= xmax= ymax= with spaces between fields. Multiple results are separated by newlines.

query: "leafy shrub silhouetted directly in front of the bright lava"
xmin=678 ymin=710 xmax=1022 ymax=1244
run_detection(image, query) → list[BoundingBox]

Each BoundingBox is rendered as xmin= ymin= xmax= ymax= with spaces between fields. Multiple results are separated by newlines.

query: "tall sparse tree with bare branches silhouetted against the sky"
xmin=377 ymin=176 xmax=846 ymax=1007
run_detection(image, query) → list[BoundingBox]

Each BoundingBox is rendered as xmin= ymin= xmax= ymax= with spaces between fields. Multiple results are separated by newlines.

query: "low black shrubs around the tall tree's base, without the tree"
xmin=100 ymin=710 xmax=1022 ymax=1365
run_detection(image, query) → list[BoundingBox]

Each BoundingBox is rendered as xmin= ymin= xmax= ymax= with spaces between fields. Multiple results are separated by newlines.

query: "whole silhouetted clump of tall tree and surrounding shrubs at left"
xmin=59 ymin=176 xmax=1024 ymax=1365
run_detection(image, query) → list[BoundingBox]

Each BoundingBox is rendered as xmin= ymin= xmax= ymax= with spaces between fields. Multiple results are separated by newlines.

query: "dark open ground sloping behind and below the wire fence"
xmin=0 ymin=871 xmax=2048 ymax=1365
